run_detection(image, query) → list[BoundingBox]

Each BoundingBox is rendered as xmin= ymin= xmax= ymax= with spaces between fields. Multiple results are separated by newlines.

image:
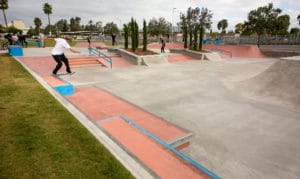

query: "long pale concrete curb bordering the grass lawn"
xmin=13 ymin=57 xmax=155 ymax=178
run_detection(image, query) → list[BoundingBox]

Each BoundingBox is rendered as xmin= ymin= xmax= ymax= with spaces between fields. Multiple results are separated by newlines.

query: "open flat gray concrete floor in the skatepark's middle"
xmin=63 ymin=59 xmax=300 ymax=179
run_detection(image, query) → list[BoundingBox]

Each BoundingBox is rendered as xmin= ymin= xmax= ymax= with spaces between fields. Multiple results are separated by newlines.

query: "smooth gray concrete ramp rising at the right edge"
xmin=236 ymin=56 xmax=300 ymax=109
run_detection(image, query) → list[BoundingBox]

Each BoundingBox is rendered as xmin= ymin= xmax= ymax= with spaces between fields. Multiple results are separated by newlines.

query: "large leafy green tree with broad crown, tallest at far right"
xmin=245 ymin=3 xmax=281 ymax=45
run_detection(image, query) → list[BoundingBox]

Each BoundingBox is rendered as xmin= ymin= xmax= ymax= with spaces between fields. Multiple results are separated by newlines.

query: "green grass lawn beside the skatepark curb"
xmin=0 ymin=54 xmax=133 ymax=179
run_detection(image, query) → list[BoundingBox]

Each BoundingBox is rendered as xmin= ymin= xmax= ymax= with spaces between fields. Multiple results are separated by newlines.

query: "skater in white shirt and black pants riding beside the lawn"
xmin=51 ymin=38 xmax=80 ymax=76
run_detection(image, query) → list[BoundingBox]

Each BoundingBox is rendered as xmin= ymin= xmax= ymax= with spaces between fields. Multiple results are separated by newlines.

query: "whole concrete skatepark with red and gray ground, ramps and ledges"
xmin=11 ymin=44 xmax=300 ymax=178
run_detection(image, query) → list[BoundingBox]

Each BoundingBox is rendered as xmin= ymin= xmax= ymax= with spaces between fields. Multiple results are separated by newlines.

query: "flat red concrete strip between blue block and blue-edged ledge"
xmin=67 ymin=86 xmax=188 ymax=142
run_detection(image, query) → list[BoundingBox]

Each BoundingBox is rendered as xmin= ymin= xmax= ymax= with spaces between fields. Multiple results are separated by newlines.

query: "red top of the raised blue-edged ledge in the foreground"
xmin=98 ymin=118 xmax=210 ymax=179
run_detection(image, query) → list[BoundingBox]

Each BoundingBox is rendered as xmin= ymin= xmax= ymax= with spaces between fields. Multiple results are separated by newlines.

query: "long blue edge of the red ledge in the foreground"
xmin=116 ymin=115 xmax=221 ymax=179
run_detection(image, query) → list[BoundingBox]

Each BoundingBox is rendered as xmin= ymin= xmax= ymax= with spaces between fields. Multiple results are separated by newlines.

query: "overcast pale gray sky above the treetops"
xmin=0 ymin=0 xmax=300 ymax=31
